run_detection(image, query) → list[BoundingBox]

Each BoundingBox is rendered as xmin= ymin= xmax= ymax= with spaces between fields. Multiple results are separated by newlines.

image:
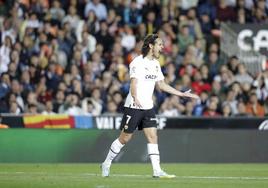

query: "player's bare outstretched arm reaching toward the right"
xmin=156 ymin=80 xmax=199 ymax=99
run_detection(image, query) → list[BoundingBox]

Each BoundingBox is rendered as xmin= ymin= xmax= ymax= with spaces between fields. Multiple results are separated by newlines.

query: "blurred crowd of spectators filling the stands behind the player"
xmin=0 ymin=0 xmax=268 ymax=117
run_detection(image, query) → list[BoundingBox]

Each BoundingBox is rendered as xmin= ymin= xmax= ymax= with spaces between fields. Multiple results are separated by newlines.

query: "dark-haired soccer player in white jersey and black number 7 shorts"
xmin=101 ymin=34 xmax=199 ymax=178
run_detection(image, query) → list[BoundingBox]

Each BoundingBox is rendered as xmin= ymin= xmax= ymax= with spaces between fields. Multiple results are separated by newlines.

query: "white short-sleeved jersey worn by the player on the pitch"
xmin=125 ymin=55 xmax=164 ymax=110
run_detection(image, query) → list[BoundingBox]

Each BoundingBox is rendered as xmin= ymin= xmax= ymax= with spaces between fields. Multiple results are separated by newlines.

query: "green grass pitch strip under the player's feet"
xmin=0 ymin=163 xmax=268 ymax=188
